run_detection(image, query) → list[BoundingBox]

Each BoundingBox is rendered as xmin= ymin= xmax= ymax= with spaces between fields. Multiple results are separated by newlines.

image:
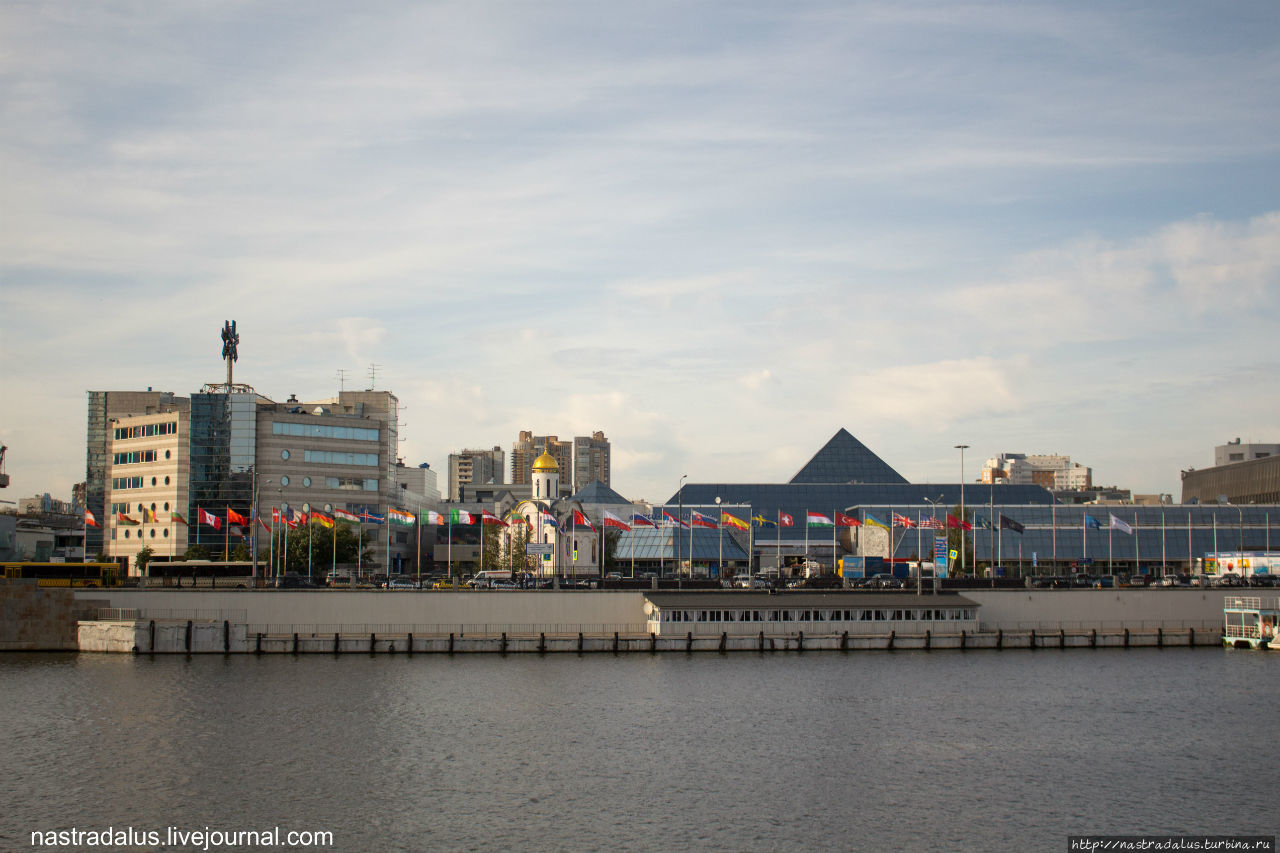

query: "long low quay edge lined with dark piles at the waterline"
xmin=79 ymin=620 xmax=1222 ymax=654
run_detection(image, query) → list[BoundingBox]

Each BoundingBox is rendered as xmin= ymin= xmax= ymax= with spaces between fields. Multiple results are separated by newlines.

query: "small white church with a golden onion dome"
xmin=503 ymin=448 xmax=600 ymax=578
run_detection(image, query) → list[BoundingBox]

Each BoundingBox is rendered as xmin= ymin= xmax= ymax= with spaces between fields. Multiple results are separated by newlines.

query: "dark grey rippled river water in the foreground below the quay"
xmin=0 ymin=649 xmax=1280 ymax=850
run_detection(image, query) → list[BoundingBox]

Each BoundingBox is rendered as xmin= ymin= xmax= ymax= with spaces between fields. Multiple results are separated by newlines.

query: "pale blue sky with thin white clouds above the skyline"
xmin=0 ymin=0 xmax=1280 ymax=501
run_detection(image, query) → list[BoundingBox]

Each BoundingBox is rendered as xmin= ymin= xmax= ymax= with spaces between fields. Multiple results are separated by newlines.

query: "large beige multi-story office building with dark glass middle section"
xmin=95 ymin=386 xmax=414 ymax=569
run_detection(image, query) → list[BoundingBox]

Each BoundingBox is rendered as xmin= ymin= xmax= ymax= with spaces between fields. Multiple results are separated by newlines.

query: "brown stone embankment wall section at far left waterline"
xmin=0 ymin=580 xmax=110 ymax=652
